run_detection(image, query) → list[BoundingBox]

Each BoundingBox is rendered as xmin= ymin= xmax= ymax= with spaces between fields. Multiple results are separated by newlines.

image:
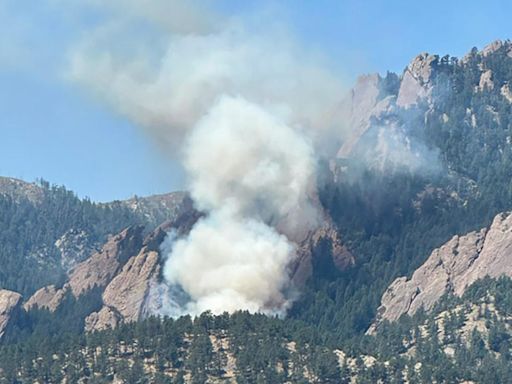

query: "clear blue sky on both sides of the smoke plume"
xmin=0 ymin=0 xmax=512 ymax=201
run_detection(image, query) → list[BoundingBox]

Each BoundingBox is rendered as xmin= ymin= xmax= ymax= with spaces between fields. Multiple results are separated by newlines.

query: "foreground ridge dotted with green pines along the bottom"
xmin=0 ymin=278 xmax=512 ymax=384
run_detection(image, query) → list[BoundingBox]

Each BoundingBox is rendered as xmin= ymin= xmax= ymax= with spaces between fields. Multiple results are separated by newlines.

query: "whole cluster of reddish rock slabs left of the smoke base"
xmin=24 ymin=204 xmax=201 ymax=331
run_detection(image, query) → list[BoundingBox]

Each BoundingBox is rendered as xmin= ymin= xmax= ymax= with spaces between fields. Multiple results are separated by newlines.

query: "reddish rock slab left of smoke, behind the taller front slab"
xmin=69 ymin=226 xmax=142 ymax=297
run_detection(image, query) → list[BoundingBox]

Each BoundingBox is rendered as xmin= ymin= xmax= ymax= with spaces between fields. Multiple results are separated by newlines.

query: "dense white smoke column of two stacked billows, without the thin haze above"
xmin=164 ymin=97 xmax=315 ymax=313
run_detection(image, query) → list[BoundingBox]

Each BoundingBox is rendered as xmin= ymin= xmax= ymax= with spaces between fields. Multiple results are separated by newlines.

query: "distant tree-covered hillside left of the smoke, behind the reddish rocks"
xmin=0 ymin=179 xmax=185 ymax=298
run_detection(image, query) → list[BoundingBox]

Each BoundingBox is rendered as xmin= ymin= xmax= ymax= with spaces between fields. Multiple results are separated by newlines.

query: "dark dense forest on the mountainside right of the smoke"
xmin=292 ymin=44 xmax=512 ymax=339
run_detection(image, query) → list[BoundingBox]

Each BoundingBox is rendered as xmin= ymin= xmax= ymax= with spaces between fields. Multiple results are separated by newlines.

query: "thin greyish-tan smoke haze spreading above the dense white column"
xmin=69 ymin=2 xmax=342 ymax=150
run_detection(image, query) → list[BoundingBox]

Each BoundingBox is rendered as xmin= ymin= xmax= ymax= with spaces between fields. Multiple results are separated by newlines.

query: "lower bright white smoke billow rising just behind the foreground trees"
xmin=164 ymin=208 xmax=294 ymax=314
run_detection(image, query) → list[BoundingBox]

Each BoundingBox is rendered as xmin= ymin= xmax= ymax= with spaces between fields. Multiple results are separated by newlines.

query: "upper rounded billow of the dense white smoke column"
xmin=184 ymin=96 xmax=315 ymax=231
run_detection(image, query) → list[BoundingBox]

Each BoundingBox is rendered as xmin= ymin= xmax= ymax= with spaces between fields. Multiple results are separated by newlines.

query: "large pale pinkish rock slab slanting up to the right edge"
xmin=370 ymin=213 xmax=512 ymax=332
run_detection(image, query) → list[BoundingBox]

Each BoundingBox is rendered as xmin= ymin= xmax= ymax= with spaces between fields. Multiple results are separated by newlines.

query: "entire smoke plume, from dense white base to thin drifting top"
xmin=69 ymin=1 xmax=343 ymax=314
